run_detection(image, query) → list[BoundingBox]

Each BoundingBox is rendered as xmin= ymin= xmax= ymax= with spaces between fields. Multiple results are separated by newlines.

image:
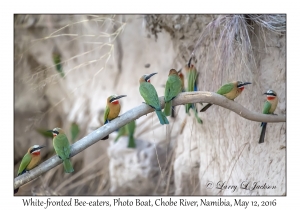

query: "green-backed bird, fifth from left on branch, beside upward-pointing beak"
xmin=164 ymin=69 xmax=182 ymax=116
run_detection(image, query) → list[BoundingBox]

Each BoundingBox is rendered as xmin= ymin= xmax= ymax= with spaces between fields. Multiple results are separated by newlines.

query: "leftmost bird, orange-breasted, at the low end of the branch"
xmin=14 ymin=145 xmax=45 ymax=193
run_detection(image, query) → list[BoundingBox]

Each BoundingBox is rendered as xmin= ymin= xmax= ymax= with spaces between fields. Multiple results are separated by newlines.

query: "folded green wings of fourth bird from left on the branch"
xmin=139 ymin=82 xmax=160 ymax=110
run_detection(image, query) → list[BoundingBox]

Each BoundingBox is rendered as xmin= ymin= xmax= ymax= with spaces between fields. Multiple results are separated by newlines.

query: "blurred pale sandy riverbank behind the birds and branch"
xmin=14 ymin=14 xmax=286 ymax=195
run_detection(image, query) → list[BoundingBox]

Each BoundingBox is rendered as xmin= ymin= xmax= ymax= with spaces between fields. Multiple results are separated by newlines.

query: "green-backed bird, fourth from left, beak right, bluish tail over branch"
xmin=139 ymin=73 xmax=169 ymax=125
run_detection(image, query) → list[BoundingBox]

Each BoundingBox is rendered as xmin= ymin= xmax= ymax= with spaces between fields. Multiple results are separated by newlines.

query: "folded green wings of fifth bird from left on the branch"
xmin=165 ymin=75 xmax=181 ymax=101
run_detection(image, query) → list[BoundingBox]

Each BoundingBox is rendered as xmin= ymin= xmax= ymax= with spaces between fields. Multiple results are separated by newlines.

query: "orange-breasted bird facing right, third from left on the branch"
xmin=101 ymin=95 xmax=126 ymax=140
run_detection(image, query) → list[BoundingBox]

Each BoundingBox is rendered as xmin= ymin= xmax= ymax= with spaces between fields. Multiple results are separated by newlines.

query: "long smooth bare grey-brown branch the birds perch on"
xmin=14 ymin=91 xmax=286 ymax=189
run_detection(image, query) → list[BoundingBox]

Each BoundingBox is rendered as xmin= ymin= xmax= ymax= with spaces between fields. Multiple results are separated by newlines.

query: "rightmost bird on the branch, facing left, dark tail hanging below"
xmin=258 ymin=90 xmax=278 ymax=144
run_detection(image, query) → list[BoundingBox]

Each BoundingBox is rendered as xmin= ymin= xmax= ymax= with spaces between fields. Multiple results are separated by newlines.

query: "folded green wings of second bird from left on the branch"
xmin=53 ymin=134 xmax=70 ymax=160
